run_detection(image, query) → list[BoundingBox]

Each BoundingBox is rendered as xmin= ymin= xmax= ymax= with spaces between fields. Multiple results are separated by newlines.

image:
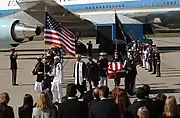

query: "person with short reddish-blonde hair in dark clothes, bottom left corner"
xmin=0 ymin=92 xmax=14 ymax=118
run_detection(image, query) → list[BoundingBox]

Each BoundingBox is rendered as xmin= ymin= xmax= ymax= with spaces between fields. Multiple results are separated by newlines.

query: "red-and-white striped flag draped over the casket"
xmin=108 ymin=62 xmax=126 ymax=79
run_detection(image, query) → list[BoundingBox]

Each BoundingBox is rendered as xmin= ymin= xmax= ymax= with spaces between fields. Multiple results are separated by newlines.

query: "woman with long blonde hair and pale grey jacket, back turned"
xmin=32 ymin=92 xmax=51 ymax=118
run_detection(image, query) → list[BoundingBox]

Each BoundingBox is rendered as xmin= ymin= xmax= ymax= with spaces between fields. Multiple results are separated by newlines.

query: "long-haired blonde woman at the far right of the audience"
xmin=161 ymin=96 xmax=180 ymax=118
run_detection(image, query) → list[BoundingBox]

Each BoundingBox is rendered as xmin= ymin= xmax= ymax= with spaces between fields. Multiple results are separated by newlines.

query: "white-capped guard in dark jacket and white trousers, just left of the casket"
xmin=98 ymin=53 xmax=108 ymax=86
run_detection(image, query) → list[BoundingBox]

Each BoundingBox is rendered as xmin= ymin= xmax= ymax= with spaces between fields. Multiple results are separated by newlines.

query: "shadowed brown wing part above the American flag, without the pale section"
xmin=18 ymin=0 xmax=95 ymax=31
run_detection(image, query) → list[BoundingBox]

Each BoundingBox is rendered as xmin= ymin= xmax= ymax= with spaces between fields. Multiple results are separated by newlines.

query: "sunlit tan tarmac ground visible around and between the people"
xmin=0 ymin=37 xmax=180 ymax=118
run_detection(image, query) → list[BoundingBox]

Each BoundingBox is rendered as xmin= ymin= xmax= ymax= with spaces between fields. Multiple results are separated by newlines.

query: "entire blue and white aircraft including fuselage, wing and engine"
xmin=0 ymin=0 xmax=180 ymax=48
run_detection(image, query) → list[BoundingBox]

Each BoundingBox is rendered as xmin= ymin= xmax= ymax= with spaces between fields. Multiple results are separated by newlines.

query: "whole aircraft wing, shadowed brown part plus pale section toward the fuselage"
xmin=18 ymin=0 xmax=150 ymax=31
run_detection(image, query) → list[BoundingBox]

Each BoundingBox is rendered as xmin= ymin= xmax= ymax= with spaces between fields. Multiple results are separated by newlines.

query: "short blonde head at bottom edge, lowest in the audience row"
xmin=137 ymin=106 xmax=149 ymax=118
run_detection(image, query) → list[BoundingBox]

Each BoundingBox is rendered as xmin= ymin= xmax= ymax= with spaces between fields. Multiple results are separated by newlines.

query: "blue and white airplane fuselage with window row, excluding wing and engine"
xmin=0 ymin=0 xmax=180 ymax=28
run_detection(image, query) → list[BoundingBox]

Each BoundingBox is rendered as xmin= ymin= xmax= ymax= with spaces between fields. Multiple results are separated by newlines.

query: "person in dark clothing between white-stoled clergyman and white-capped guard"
xmin=87 ymin=57 xmax=100 ymax=89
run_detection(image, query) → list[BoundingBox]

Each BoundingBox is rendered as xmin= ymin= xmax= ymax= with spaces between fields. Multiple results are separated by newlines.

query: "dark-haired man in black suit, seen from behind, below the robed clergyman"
xmin=58 ymin=84 xmax=88 ymax=118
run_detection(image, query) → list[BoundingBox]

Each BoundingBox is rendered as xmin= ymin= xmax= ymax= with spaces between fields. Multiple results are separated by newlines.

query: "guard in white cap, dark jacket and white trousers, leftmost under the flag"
xmin=32 ymin=57 xmax=44 ymax=92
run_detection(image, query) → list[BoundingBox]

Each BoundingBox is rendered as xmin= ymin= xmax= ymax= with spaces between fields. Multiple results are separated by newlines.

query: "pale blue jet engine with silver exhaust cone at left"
xmin=0 ymin=19 xmax=41 ymax=48
